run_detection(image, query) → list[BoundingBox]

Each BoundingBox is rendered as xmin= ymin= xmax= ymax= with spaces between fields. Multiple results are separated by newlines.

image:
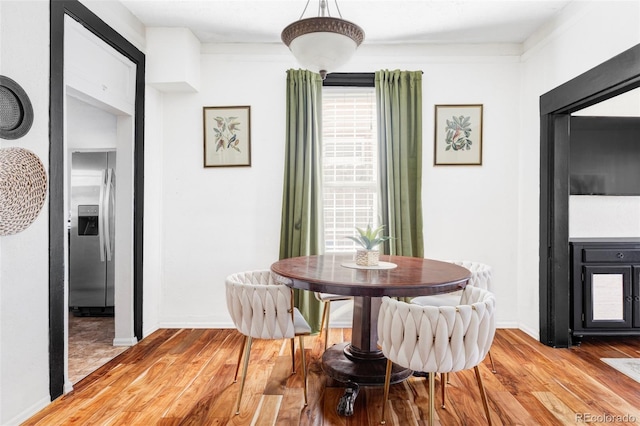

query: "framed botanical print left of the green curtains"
xmin=202 ymin=105 xmax=251 ymax=167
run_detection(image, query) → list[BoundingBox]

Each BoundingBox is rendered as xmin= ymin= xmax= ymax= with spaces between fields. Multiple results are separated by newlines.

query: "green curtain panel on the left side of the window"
xmin=280 ymin=70 xmax=323 ymax=333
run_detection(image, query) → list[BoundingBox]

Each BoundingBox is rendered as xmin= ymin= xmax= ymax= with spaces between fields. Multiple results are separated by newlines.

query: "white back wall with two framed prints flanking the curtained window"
xmin=155 ymin=40 xmax=520 ymax=327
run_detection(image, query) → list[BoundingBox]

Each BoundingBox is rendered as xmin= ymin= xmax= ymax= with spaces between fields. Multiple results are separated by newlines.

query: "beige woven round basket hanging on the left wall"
xmin=0 ymin=148 xmax=47 ymax=235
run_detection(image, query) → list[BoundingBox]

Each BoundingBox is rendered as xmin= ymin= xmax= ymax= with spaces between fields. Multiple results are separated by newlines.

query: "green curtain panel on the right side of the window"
xmin=375 ymin=70 xmax=424 ymax=257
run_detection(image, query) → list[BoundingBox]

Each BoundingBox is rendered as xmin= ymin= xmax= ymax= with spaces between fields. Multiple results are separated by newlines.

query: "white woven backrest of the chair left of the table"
xmin=225 ymin=270 xmax=295 ymax=339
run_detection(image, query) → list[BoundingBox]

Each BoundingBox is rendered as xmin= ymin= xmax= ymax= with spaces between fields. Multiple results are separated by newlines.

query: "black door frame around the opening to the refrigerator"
xmin=49 ymin=0 xmax=145 ymax=400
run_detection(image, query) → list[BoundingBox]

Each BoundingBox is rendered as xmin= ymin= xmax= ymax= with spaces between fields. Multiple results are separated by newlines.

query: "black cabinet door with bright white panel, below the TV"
xmin=584 ymin=266 xmax=633 ymax=328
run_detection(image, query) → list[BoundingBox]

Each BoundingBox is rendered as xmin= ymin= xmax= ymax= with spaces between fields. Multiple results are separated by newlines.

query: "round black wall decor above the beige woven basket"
xmin=0 ymin=75 xmax=33 ymax=139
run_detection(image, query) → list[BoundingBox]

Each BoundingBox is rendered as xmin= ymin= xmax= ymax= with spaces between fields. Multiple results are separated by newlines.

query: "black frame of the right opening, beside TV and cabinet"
xmin=539 ymin=44 xmax=640 ymax=347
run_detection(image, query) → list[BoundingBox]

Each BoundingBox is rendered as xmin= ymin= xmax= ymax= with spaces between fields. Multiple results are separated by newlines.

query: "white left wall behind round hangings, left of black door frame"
xmin=0 ymin=1 xmax=49 ymax=425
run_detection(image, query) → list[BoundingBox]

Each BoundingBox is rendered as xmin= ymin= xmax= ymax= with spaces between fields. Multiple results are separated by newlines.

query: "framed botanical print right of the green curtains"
xmin=433 ymin=104 xmax=483 ymax=166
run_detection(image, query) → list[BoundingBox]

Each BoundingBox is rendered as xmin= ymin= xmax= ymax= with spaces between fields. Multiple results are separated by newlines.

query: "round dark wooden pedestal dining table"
xmin=271 ymin=255 xmax=471 ymax=415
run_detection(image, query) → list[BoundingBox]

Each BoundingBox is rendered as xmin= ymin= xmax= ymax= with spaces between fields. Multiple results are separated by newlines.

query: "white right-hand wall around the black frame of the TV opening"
xmin=516 ymin=1 xmax=640 ymax=336
